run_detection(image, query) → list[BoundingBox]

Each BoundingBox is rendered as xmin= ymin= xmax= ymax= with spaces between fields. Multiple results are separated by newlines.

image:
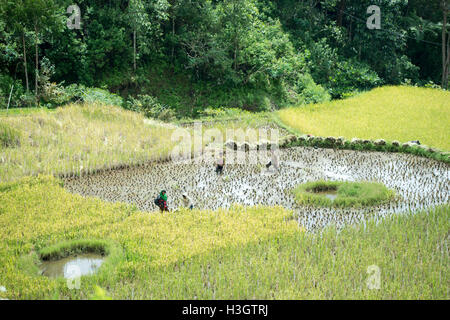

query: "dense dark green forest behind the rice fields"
xmin=0 ymin=0 xmax=450 ymax=118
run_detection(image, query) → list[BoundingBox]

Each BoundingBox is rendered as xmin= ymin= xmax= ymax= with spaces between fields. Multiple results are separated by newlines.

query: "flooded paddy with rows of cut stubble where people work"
xmin=65 ymin=147 xmax=450 ymax=230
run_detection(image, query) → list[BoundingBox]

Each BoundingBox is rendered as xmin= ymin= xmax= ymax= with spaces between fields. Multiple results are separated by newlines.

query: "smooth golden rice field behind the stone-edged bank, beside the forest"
xmin=278 ymin=86 xmax=450 ymax=151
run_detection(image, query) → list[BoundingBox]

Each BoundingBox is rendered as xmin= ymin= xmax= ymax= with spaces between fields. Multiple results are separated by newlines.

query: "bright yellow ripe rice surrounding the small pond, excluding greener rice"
xmin=0 ymin=176 xmax=302 ymax=299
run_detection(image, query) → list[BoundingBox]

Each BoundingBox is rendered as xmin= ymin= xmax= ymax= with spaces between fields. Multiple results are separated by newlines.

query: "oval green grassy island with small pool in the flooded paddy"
xmin=292 ymin=180 xmax=395 ymax=207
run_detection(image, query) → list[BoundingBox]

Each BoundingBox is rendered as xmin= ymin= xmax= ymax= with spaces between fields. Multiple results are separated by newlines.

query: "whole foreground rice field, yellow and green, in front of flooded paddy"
xmin=0 ymin=176 xmax=450 ymax=299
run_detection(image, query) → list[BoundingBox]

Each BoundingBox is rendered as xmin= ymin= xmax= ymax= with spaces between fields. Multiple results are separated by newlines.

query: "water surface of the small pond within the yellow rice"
xmin=40 ymin=253 xmax=104 ymax=278
